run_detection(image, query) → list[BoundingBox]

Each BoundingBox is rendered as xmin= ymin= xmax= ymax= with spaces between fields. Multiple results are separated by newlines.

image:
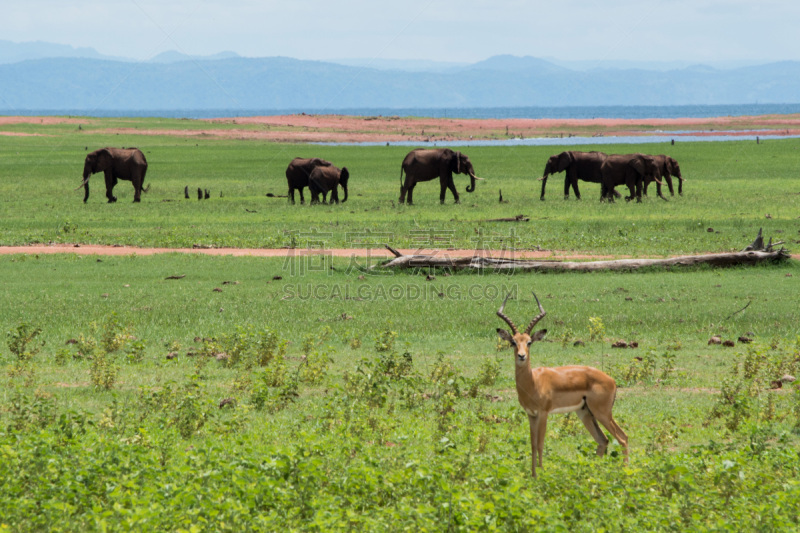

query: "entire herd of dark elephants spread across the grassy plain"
xmin=78 ymin=148 xmax=684 ymax=205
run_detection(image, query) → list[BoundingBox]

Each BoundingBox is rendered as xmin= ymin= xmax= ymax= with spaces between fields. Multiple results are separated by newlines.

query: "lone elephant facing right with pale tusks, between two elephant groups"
xmin=400 ymin=148 xmax=482 ymax=205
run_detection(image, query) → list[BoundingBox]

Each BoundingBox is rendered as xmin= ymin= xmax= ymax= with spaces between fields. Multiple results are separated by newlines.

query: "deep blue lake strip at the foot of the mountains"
xmin=0 ymin=104 xmax=800 ymax=119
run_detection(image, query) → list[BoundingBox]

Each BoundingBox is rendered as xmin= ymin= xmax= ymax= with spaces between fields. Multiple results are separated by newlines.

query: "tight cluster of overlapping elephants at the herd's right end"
xmin=540 ymin=152 xmax=684 ymax=202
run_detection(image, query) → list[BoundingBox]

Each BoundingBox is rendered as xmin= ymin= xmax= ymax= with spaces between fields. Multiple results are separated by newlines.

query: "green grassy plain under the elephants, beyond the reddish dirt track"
xmin=0 ymin=119 xmax=800 ymax=255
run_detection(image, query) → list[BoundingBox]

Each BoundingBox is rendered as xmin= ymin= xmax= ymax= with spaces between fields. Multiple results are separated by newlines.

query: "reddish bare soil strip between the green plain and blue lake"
xmin=6 ymin=113 xmax=800 ymax=143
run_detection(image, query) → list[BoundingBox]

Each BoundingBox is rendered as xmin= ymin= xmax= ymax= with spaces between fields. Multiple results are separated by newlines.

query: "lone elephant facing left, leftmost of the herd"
xmin=78 ymin=148 xmax=150 ymax=203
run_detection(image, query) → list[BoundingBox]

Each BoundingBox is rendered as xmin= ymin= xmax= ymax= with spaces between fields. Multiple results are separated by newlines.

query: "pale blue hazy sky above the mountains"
xmin=6 ymin=0 xmax=800 ymax=63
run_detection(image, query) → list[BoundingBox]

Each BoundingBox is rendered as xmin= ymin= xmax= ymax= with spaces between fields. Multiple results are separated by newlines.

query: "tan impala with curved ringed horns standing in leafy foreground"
xmin=497 ymin=293 xmax=628 ymax=477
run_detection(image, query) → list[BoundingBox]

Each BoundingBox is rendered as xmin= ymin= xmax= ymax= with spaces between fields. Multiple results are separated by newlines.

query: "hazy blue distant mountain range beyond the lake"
xmin=0 ymin=41 xmax=800 ymax=114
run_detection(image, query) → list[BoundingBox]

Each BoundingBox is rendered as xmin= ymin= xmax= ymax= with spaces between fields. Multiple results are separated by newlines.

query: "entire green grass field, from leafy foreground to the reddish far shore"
xmin=0 ymin=121 xmax=800 ymax=531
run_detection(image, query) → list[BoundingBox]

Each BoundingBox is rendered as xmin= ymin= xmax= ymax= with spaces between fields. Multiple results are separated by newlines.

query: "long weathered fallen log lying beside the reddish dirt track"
xmin=376 ymin=230 xmax=791 ymax=272
